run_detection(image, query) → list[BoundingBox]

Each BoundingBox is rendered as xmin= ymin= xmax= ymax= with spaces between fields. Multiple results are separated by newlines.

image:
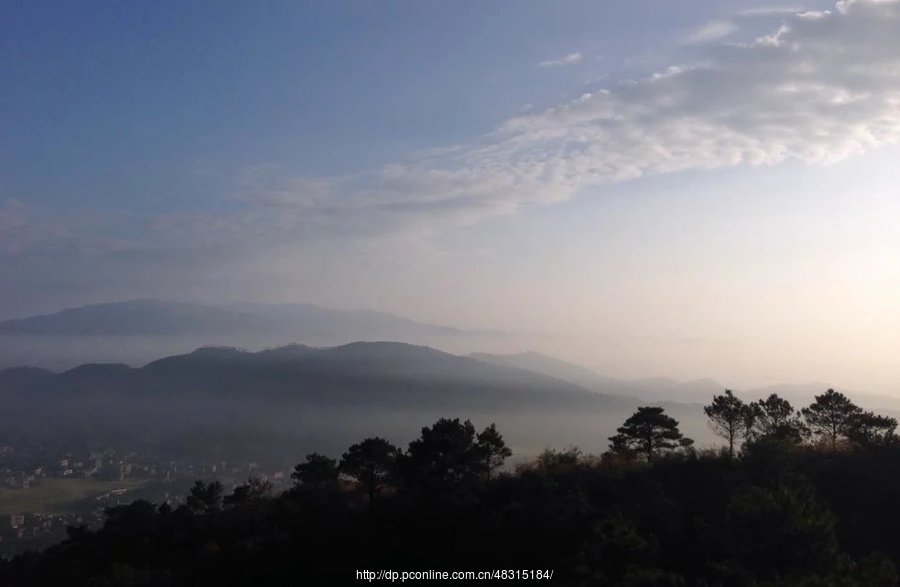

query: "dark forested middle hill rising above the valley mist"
xmin=0 ymin=342 xmax=622 ymax=409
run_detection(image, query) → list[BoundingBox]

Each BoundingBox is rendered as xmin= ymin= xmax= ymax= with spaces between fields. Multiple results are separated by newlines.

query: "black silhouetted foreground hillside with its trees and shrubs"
xmin=0 ymin=390 xmax=900 ymax=587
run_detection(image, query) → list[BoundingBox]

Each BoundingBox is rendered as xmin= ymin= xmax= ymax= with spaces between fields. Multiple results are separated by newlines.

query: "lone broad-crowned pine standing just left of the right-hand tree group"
xmin=609 ymin=407 xmax=690 ymax=462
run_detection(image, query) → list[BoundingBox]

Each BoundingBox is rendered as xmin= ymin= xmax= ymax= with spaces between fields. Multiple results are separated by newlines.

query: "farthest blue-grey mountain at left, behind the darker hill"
xmin=0 ymin=300 xmax=505 ymax=371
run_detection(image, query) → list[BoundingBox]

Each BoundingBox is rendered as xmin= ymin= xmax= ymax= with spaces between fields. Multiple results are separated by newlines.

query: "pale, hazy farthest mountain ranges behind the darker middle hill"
xmin=0 ymin=300 xmax=884 ymax=416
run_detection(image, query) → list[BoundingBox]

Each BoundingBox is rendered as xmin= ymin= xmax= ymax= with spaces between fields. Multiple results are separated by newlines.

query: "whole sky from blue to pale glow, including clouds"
xmin=0 ymin=0 xmax=900 ymax=395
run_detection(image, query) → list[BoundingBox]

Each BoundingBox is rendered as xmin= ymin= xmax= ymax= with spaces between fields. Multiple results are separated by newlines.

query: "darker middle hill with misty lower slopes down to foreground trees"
xmin=0 ymin=342 xmax=652 ymax=458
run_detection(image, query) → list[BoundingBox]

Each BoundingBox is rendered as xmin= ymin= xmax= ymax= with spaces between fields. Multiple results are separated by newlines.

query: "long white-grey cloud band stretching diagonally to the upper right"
xmin=6 ymin=0 xmax=900 ymax=268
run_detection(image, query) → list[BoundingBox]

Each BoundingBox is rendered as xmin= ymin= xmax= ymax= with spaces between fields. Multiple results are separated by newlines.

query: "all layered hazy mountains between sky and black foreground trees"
xmin=0 ymin=301 xmax=900 ymax=455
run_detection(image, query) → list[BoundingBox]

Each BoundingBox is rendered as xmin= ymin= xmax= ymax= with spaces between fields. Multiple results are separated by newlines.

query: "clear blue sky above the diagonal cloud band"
xmin=0 ymin=0 xmax=828 ymax=210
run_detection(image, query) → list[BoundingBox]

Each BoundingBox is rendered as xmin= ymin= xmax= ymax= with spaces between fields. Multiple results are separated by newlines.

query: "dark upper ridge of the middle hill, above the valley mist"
xmin=0 ymin=341 xmax=624 ymax=406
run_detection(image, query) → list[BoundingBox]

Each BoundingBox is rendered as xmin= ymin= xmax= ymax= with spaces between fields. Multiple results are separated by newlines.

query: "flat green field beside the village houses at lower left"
xmin=0 ymin=478 xmax=145 ymax=515
